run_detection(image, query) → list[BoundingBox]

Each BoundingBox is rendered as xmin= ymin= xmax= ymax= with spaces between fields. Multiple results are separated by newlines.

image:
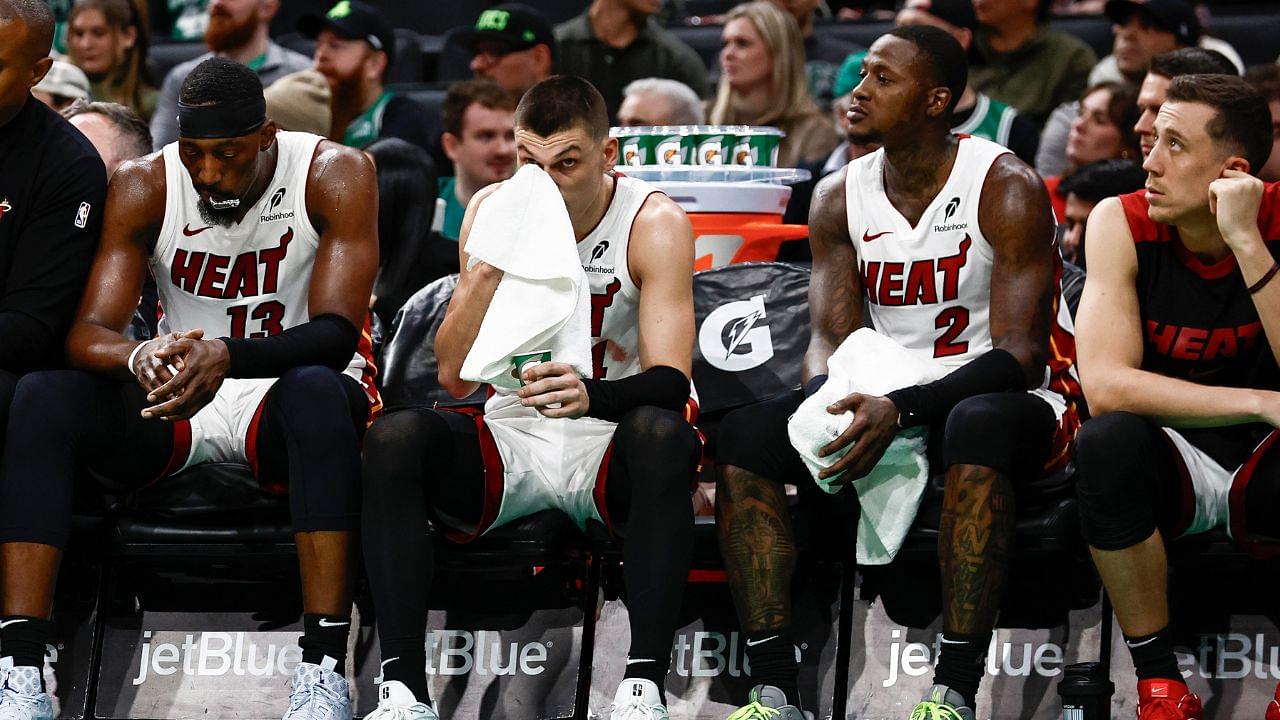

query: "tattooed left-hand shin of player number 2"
xmin=716 ymin=468 xmax=796 ymax=633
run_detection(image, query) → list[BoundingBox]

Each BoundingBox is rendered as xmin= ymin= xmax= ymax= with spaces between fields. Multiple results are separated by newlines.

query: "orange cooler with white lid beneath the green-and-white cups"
xmin=618 ymin=167 xmax=809 ymax=270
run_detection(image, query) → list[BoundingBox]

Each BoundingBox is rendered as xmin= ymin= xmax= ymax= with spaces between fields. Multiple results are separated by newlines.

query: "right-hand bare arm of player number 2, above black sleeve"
xmin=978 ymin=155 xmax=1057 ymax=387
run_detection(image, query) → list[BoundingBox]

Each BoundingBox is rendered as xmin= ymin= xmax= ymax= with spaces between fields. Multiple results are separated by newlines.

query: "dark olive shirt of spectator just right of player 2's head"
xmin=969 ymin=27 xmax=1098 ymax=126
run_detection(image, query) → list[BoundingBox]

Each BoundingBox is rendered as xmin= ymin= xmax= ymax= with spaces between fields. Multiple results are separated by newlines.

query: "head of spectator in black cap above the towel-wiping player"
xmin=470 ymin=3 xmax=552 ymax=97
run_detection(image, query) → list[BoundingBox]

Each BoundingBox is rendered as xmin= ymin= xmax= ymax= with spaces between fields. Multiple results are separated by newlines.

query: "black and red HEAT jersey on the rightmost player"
xmin=1120 ymin=183 xmax=1280 ymax=468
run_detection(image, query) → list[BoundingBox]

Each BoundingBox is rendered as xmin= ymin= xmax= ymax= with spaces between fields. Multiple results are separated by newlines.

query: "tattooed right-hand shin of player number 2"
xmin=938 ymin=465 xmax=1014 ymax=635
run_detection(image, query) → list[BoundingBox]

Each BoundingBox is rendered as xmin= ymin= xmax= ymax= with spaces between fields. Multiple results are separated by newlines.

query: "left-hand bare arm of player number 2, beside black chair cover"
xmin=801 ymin=168 xmax=863 ymax=383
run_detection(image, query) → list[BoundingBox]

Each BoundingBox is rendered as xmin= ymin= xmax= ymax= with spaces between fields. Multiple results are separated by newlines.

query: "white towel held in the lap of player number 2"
xmin=787 ymin=328 xmax=947 ymax=565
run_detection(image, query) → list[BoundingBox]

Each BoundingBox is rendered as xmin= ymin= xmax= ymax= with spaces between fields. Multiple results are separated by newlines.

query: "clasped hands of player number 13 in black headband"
xmin=129 ymin=329 xmax=230 ymax=421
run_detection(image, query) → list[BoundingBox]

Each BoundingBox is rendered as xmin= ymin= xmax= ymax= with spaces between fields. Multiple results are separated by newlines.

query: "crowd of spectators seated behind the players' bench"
xmin=15 ymin=0 xmax=1280 ymax=323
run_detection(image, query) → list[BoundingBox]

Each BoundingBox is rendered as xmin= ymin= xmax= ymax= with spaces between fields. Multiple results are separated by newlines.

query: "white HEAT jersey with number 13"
xmin=150 ymin=132 xmax=378 ymax=400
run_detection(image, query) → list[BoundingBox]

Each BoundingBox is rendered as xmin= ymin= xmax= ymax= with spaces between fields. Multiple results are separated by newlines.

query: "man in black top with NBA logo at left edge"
xmin=0 ymin=0 xmax=106 ymax=438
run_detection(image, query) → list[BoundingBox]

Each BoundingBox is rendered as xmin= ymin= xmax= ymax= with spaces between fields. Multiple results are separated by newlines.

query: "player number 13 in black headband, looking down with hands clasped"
xmin=0 ymin=58 xmax=378 ymax=720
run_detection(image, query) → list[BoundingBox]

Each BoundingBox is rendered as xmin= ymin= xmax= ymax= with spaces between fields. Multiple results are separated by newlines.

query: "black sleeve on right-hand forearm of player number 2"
xmin=886 ymin=347 xmax=1027 ymax=428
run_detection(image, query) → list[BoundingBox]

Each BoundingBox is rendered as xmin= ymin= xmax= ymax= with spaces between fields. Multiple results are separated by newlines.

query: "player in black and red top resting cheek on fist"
xmin=1076 ymin=74 xmax=1280 ymax=720
